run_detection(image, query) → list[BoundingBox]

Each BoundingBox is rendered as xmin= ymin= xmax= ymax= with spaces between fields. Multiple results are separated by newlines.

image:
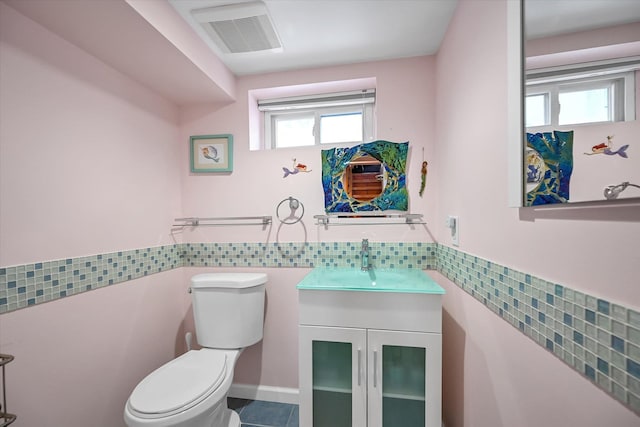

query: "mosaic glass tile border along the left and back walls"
xmin=0 ymin=242 xmax=436 ymax=314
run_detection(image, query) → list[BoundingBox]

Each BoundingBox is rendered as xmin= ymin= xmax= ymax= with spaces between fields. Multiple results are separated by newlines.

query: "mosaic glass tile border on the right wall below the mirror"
xmin=436 ymin=245 xmax=640 ymax=415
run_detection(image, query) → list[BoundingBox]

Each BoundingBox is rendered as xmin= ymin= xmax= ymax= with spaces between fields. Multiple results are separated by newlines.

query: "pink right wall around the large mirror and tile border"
xmin=435 ymin=0 xmax=640 ymax=427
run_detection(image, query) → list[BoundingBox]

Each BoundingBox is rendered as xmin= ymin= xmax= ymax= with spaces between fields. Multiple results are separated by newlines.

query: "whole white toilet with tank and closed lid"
xmin=124 ymin=273 xmax=267 ymax=427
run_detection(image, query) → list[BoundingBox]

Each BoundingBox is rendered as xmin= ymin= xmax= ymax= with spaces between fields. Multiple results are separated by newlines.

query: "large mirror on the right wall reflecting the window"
xmin=519 ymin=0 xmax=640 ymax=206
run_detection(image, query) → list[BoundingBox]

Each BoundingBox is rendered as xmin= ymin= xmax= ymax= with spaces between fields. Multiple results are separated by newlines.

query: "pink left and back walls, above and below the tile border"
xmin=0 ymin=3 xmax=435 ymax=426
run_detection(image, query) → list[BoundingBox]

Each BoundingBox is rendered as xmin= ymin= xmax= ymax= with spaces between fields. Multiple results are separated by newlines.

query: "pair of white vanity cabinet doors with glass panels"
xmin=300 ymin=326 xmax=442 ymax=427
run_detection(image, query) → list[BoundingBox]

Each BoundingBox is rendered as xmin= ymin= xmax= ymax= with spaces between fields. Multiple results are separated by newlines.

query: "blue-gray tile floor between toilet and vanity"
xmin=227 ymin=397 xmax=299 ymax=427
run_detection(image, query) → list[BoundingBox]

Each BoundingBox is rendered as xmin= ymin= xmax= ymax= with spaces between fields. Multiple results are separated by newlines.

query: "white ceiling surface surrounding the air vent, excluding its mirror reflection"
xmin=168 ymin=0 xmax=458 ymax=75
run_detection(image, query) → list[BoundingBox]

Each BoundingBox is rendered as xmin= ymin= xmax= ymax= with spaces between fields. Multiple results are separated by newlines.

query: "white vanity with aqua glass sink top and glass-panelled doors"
xmin=297 ymin=267 xmax=444 ymax=427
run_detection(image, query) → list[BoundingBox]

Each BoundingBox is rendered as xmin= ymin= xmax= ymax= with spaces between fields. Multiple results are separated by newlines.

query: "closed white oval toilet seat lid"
xmin=127 ymin=349 xmax=227 ymax=419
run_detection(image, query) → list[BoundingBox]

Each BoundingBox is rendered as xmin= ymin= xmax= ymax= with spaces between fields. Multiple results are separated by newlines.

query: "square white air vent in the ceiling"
xmin=191 ymin=1 xmax=282 ymax=53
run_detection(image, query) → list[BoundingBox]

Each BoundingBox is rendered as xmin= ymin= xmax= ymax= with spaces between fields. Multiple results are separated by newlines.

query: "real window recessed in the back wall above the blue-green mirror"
xmin=258 ymin=89 xmax=375 ymax=148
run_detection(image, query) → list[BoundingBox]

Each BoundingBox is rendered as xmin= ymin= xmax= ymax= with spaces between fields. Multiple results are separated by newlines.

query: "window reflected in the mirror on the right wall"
xmin=525 ymin=59 xmax=638 ymax=127
